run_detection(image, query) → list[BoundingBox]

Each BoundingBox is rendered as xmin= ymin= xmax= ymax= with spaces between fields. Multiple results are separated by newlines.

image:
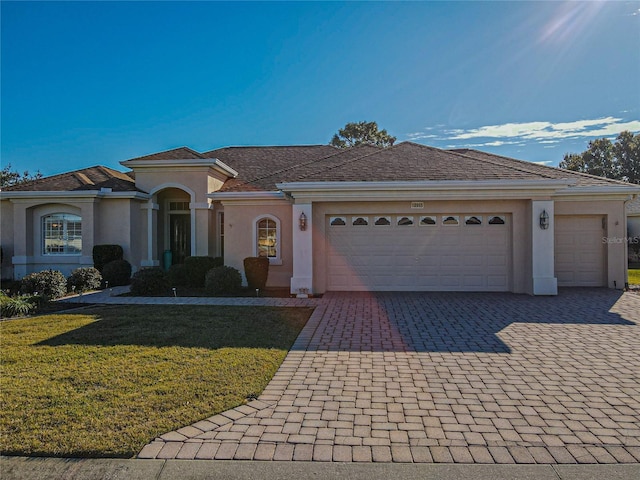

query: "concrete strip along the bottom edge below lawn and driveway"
xmin=0 ymin=457 xmax=640 ymax=480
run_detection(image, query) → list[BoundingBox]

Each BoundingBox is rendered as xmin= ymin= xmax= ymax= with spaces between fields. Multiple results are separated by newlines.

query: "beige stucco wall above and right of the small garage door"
xmin=555 ymin=200 xmax=627 ymax=289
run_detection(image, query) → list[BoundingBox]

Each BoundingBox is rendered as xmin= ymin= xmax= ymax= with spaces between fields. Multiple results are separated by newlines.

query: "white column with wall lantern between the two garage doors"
xmin=531 ymin=200 xmax=558 ymax=295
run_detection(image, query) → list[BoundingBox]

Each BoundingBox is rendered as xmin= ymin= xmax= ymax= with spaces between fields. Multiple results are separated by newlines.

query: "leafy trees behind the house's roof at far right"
xmin=559 ymin=131 xmax=640 ymax=184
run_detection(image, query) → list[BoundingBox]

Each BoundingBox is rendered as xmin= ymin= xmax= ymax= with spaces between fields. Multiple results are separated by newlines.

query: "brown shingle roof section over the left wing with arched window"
xmin=3 ymin=166 xmax=138 ymax=192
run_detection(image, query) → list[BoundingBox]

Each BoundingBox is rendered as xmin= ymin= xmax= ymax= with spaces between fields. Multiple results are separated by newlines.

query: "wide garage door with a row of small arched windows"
xmin=326 ymin=213 xmax=511 ymax=291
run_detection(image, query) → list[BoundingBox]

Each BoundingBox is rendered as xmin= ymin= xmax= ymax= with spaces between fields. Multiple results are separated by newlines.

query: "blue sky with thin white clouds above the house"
xmin=0 ymin=1 xmax=640 ymax=175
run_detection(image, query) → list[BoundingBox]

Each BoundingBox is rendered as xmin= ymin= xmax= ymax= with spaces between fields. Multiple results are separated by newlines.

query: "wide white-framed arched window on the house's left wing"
xmin=42 ymin=213 xmax=82 ymax=255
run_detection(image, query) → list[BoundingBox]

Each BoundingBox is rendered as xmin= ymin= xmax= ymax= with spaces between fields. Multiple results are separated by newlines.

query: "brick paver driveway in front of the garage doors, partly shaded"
xmin=139 ymin=289 xmax=640 ymax=463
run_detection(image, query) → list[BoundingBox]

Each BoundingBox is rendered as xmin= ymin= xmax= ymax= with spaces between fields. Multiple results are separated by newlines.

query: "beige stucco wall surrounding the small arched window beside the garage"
xmin=219 ymin=200 xmax=293 ymax=287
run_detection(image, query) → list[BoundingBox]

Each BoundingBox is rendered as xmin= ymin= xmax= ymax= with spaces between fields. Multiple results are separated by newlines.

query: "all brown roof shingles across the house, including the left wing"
xmin=4 ymin=142 xmax=628 ymax=192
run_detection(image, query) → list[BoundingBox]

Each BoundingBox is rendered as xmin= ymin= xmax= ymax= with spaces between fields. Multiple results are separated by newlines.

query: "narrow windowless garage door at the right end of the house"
xmin=555 ymin=215 xmax=606 ymax=287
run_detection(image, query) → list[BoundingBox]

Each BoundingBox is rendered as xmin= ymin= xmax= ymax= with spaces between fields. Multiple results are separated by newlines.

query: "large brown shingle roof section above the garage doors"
xmin=215 ymin=142 xmax=626 ymax=191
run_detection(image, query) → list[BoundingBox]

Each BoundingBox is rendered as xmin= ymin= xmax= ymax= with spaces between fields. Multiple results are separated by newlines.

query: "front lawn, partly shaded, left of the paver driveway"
xmin=0 ymin=305 xmax=311 ymax=457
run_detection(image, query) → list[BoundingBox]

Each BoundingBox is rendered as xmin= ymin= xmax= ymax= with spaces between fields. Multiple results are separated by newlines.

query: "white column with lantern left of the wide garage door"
xmin=291 ymin=203 xmax=313 ymax=298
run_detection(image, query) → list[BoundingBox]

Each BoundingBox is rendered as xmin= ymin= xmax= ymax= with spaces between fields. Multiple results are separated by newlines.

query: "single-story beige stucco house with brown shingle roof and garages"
xmin=0 ymin=142 xmax=640 ymax=296
